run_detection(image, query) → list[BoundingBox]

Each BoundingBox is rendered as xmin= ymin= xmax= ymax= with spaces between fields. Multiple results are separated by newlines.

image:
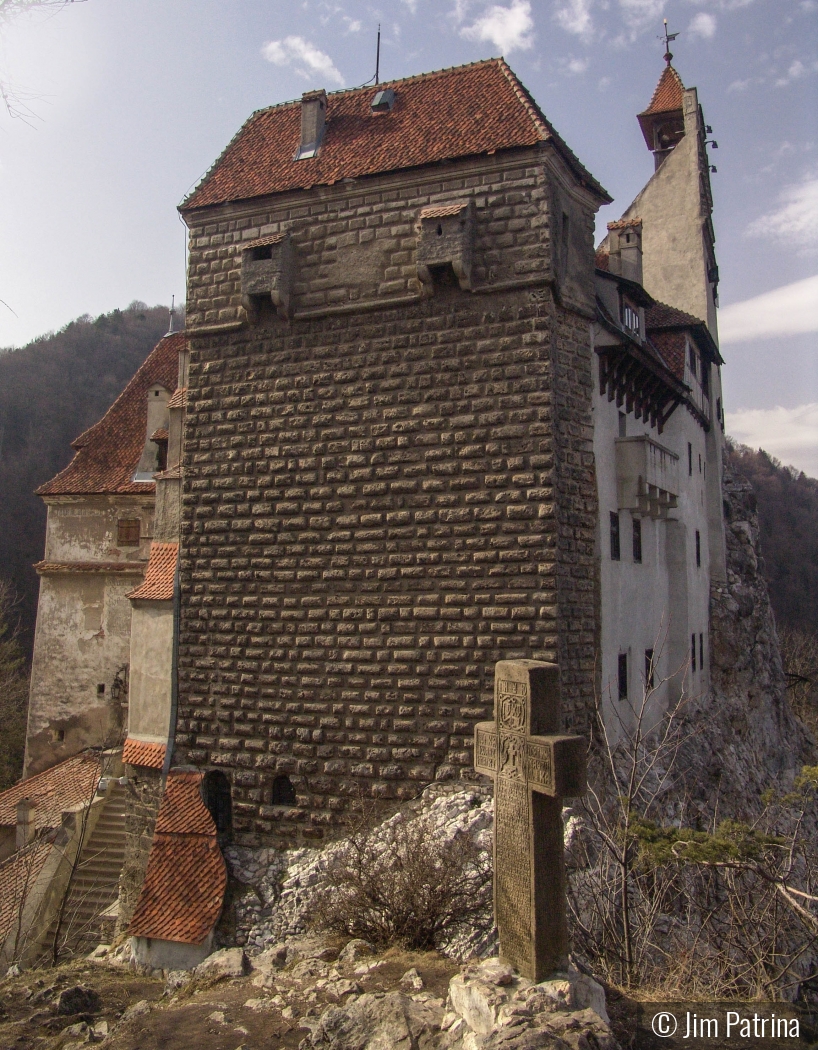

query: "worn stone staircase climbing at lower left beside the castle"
xmin=42 ymin=783 xmax=126 ymax=959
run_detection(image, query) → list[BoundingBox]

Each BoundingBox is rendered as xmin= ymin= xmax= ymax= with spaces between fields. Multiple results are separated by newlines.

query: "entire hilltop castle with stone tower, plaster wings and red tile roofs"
xmin=0 ymin=49 xmax=726 ymax=965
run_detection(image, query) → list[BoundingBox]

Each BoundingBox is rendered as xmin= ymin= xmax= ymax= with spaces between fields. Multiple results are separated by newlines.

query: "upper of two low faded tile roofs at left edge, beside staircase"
xmin=0 ymin=752 xmax=102 ymax=827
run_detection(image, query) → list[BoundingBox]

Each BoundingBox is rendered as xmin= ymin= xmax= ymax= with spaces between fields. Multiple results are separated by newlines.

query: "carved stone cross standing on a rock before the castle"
xmin=475 ymin=659 xmax=587 ymax=982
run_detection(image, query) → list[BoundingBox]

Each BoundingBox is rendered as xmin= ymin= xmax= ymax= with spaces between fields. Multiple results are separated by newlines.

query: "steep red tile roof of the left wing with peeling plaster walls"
xmin=37 ymin=332 xmax=185 ymax=496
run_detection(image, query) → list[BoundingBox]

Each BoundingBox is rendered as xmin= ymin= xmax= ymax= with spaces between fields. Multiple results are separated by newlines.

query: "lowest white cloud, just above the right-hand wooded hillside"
xmin=726 ymin=403 xmax=818 ymax=478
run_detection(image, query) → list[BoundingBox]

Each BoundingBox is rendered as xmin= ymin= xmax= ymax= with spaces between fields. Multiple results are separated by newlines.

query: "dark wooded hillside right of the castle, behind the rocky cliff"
xmin=728 ymin=445 xmax=818 ymax=633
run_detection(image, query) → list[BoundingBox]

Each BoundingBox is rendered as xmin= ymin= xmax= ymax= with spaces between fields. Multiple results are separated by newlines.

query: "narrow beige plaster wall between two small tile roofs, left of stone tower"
xmin=128 ymin=601 xmax=173 ymax=743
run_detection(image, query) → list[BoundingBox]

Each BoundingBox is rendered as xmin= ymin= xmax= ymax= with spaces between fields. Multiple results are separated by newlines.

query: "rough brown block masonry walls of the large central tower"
xmin=174 ymin=71 xmax=599 ymax=845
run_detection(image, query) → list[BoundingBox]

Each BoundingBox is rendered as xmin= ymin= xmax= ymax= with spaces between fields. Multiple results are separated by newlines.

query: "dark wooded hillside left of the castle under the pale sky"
xmin=0 ymin=302 xmax=173 ymax=653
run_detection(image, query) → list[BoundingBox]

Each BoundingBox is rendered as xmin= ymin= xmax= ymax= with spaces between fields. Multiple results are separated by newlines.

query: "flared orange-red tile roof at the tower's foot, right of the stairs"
xmin=128 ymin=772 xmax=227 ymax=944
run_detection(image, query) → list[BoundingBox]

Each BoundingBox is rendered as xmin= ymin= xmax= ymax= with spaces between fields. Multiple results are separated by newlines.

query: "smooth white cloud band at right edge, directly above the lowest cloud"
xmin=718 ymin=274 xmax=818 ymax=345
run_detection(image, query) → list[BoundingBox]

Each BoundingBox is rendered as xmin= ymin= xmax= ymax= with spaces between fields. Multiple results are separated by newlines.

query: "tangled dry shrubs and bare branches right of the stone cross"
xmin=568 ymin=655 xmax=818 ymax=1000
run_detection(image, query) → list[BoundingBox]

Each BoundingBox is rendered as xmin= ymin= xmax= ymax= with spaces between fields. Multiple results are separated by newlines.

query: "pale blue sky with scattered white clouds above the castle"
xmin=0 ymin=0 xmax=818 ymax=477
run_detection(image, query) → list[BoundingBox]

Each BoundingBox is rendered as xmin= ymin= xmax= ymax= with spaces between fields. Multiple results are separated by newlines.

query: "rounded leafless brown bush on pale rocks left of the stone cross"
xmin=311 ymin=814 xmax=491 ymax=950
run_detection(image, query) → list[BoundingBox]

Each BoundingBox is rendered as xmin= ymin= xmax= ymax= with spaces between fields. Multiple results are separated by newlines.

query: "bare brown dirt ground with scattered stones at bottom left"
xmin=0 ymin=950 xmax=458 ymax=1050
